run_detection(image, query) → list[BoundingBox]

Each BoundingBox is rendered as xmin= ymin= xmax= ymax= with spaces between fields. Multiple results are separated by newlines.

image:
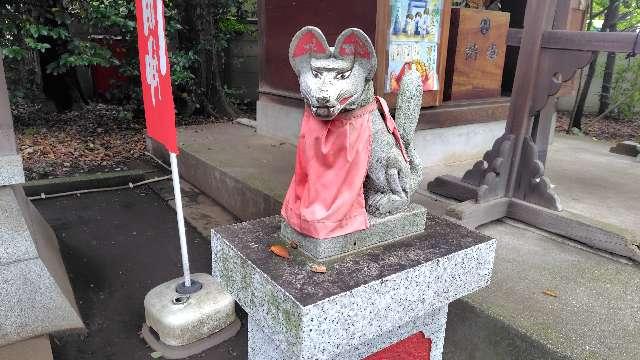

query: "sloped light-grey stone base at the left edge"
xmin=0 ymin=185 xmax=84 ymax=346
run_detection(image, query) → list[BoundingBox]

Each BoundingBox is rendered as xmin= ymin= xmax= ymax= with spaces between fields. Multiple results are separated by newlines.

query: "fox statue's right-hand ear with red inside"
xmin=333 ymin=28 xmax=378 ymax=80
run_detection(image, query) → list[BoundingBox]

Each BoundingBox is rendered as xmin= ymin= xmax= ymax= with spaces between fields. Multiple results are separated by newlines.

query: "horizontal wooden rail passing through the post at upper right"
xmin=507 ymin=29 xmax=640 ymax=53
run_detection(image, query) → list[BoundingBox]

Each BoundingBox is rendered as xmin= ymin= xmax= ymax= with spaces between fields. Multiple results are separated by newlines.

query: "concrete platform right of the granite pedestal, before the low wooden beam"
xmin=445 ymin=222 xmax=640 ymax=360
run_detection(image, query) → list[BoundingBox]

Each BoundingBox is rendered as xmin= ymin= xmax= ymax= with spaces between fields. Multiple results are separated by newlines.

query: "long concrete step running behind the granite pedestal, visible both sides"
xmin=150 ymin=124 xmax=640 ymax=359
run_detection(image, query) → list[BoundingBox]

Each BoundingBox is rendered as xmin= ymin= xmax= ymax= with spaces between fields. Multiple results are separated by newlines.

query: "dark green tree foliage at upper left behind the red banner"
xmin=0 ymin=0 xmax=256 ymax=114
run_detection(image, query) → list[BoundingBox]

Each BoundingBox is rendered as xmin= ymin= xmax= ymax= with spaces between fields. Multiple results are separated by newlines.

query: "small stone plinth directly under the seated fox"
xmin=280 ymin=204 xmax=427 ymax=260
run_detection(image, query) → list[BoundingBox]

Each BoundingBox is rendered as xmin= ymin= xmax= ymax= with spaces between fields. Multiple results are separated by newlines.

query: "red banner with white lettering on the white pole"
xmin=136 ymin=0 xmax=178 ymax=154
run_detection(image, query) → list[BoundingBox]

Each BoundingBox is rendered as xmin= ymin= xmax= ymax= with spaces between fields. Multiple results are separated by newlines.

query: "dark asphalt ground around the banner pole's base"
xmin=34 ymin=187 xmax=247 ymax=360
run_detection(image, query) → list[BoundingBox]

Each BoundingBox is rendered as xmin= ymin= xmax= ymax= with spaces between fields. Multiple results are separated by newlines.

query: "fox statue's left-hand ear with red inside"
xmin=289 ymin=26 xmax=331 ymax=75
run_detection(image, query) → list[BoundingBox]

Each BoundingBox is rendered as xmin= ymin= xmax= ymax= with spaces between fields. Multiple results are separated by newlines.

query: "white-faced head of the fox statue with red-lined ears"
xmin=289 ymin=27 xmax=376 ymax=120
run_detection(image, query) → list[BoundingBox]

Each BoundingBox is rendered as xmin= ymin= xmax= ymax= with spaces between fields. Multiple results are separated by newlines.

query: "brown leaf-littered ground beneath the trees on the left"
xmin=12 ymin=104 xmax=234 ymax=180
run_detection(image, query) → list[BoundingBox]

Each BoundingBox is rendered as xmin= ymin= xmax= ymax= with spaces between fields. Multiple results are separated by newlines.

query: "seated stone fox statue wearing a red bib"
xmin=282 ymin=26 xmax=422 ymax=238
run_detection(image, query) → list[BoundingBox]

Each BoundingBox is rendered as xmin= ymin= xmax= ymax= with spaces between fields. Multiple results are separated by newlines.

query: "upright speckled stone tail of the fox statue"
xmin=395 ymin=70 xmax=422 ymax=190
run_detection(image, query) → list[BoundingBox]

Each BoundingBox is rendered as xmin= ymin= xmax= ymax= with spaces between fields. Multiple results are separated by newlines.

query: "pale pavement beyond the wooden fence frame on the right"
xmin=420 ymin=134 xmax=640 ymax=237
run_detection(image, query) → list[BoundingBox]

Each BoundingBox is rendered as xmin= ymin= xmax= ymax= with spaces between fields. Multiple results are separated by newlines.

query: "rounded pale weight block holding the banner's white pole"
xmin=142 ymin=273 xmax=240 ymax=359
